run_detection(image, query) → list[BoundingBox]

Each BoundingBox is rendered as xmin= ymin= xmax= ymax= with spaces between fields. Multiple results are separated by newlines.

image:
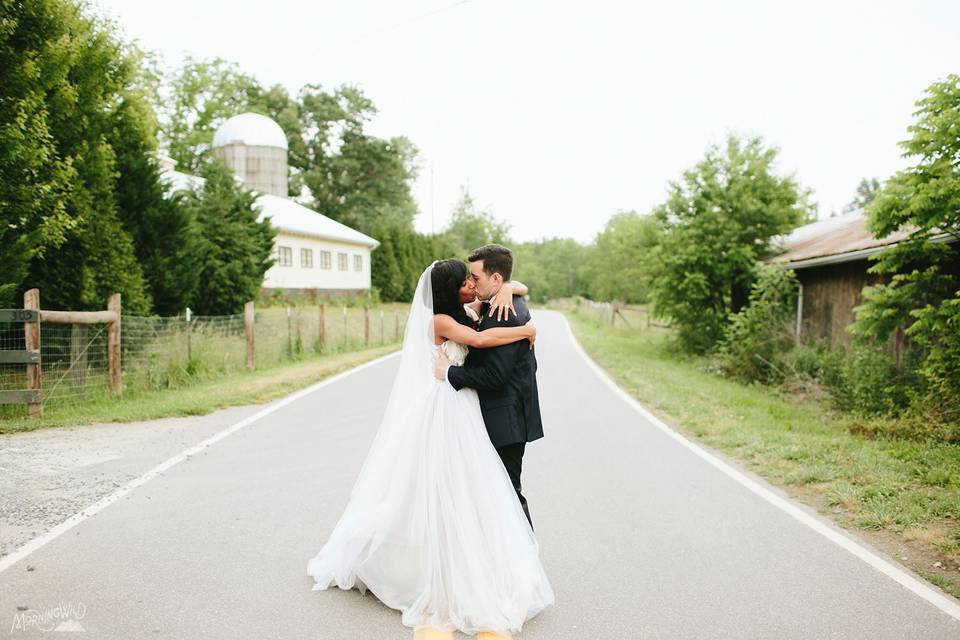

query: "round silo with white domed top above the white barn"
xmin=213 ymin=113 xmax=287 ymax=198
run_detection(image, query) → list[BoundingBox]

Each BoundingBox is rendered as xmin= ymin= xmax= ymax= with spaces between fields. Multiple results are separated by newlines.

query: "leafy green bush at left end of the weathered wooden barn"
xmin=717 ymin=266 xmax=798 ymax=382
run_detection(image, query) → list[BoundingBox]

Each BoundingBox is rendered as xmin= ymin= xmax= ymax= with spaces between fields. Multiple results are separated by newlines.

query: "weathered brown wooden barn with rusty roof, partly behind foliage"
xmin=770 ymin=211 xmax=955 ymax=347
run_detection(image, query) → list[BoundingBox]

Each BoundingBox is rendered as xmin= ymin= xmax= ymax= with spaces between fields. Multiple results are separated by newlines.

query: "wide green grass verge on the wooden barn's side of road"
xmin=566 ymin=310 xmax=960 ymax=597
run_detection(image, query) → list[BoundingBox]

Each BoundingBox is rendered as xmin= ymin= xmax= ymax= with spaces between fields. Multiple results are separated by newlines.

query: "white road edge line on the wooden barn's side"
xmin=559 ymin=313 xmax=960 ymax=620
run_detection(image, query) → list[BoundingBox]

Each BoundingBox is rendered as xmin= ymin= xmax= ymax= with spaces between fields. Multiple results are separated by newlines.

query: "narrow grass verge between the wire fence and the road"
xmin=0 ymin=344 xmax=398 ymax=434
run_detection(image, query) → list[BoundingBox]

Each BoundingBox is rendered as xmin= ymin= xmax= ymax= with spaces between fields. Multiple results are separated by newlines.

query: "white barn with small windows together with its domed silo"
xmin=162 ymin=113 xmax=380 ymax=296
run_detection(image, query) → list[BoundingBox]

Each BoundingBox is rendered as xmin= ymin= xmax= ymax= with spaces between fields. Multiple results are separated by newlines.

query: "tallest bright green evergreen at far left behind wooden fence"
xmin=0 ymin=0 xmax=151 ymax=313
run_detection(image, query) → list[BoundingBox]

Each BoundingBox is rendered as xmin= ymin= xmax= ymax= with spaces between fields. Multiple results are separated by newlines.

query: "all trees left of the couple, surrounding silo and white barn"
xmin=0 ymin=0 xmax=455 ymax=315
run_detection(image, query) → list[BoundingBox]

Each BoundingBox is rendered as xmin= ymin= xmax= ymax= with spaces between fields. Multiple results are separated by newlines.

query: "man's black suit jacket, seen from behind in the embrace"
xmin=447 ymin=296 xmax=543 ymax=447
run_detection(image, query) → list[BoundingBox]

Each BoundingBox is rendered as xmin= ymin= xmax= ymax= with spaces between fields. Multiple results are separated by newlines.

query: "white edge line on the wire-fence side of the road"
xmin=0 ymin=351 xmax=400 ymax=573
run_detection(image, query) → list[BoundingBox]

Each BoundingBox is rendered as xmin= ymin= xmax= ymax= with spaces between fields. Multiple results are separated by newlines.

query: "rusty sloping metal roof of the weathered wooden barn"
xmin=770 ymin=210 xmax=952 ymax=269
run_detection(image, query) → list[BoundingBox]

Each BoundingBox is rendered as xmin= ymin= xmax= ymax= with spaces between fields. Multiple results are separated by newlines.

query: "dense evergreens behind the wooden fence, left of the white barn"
xmin=0 ymin=0 xmax=275 ymax=315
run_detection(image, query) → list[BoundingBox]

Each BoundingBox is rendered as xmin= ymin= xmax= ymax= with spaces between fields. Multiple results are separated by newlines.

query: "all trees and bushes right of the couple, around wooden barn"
xmin=486 ymin=74 xmax=960 ymax=442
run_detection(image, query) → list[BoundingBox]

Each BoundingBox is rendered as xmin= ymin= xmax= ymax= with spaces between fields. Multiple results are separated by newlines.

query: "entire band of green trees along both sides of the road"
xmin=0 ymin=0 xmax=960 ymax=432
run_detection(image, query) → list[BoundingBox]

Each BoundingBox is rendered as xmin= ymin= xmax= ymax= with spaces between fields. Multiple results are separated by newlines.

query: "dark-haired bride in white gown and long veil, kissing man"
xmin=307 ymin=260 xmax=554 ymax=640
